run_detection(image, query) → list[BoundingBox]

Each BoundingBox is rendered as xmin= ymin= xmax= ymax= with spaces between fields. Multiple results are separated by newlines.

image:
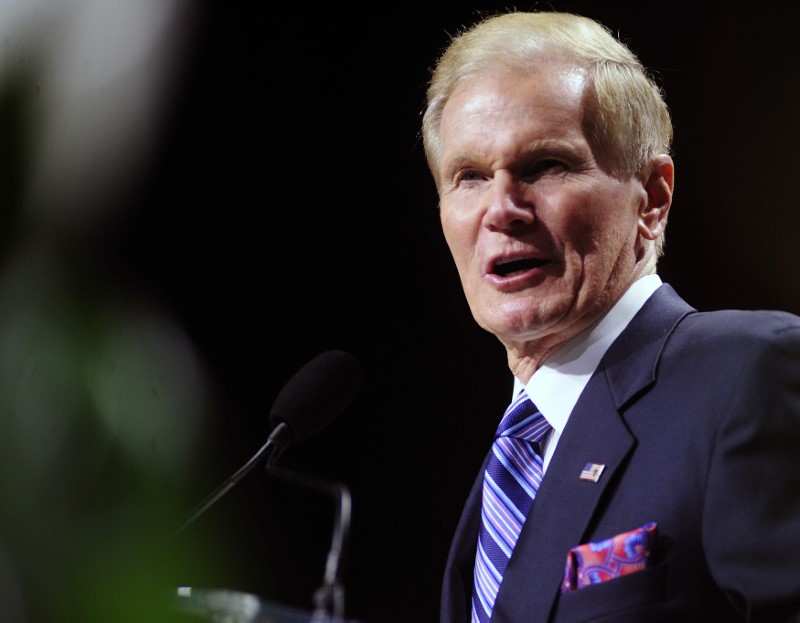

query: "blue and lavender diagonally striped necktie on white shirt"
xmin=472 ymin=389 xmax=550 ymax=623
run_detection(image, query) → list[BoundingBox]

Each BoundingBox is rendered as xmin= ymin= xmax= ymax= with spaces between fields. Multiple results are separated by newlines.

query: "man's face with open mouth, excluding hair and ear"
xmin=439 ymin=64 xmax=647 ymax=354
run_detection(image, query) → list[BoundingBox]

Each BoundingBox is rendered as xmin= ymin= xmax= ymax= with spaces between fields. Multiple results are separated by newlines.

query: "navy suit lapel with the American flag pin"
xmin=492 ymin=285 xmax=691 ymax=623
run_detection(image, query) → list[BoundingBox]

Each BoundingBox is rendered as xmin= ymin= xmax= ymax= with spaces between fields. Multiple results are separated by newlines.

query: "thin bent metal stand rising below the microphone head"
xmin=266 ymin=452 xmax=352 ymax=623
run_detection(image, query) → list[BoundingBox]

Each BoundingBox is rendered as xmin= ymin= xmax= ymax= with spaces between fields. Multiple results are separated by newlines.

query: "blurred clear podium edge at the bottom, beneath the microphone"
xmin=174 ymin=586 xmax=364 ymax=623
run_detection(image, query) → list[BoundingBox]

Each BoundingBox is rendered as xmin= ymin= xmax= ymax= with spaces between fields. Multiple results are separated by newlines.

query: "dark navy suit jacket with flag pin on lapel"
xmin=441 ymin=284 xmax=800 ymax=623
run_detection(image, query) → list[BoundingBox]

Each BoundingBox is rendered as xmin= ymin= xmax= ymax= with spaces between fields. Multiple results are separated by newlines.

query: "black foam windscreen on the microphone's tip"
xmin=269 ymin=350 xmax=363 ymax=441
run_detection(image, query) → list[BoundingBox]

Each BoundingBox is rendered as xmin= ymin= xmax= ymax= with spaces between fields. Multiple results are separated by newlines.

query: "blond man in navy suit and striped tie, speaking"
xmin=423 ymin=12 xmax=800 ymax=623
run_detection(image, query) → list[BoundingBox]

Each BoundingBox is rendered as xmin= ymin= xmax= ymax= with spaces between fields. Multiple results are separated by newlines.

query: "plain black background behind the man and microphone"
xmin=109 ymin=0 xmax=800 ymax=623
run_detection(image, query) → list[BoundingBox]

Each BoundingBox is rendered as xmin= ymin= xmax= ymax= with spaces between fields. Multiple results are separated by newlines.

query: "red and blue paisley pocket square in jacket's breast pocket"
xmin=561 ymin=522 xmax=658 ymax=593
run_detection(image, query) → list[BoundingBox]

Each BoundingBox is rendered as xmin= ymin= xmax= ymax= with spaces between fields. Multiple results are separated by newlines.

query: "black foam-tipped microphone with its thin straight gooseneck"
xmin=173 ymin=350 xmax=363 ymax=536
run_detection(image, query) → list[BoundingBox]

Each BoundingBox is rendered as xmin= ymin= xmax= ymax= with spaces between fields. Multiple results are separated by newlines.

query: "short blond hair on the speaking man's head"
xmin=422 ymin=12 xmax=672 ymax=187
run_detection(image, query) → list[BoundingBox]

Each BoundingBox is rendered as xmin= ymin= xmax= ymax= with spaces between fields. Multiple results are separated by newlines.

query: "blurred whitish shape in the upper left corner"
xmin=0 ymin=0 xmax=198 ymax=228
